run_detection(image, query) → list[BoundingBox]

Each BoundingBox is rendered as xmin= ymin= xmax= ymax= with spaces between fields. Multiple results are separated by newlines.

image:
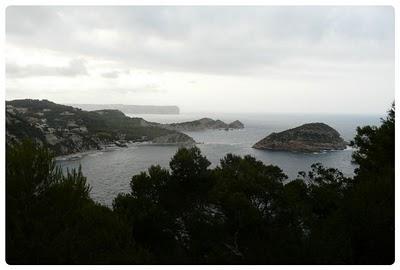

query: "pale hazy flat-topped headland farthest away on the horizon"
xmin=68 ymin=104 xmax=179 ymax=114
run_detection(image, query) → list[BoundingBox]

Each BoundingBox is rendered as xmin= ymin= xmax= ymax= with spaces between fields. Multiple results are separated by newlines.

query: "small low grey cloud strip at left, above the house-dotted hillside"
xmin=6 ymin=59 xmax=88 ymax=78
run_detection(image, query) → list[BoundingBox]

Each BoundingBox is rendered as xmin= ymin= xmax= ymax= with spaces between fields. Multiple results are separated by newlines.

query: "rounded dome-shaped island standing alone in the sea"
xmin=253 ymin=123 xmax=346 ymax=152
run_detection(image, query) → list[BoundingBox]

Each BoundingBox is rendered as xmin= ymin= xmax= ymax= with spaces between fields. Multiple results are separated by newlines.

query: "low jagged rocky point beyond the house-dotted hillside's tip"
xmin=162 ymin=118 xmax=244 ymax=131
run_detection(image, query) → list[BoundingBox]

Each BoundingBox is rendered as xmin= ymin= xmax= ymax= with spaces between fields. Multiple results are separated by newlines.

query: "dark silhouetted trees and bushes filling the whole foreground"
xmin=6 ymin=107 xmax=395 ymax=264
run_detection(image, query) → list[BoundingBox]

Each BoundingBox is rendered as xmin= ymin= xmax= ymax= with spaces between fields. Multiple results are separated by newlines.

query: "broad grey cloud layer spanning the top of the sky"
xmin=6 ymin=6 xmax=394 ymax=78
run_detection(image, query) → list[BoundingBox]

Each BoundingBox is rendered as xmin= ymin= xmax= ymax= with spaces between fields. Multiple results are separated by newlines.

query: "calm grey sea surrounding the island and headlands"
xmin=58 ymin=113 xmax=381 ymax=205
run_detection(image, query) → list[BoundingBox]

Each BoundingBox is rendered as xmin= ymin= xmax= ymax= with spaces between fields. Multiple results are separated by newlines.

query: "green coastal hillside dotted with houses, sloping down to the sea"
xmin=6 ymin=99 xmax=195 ymax=155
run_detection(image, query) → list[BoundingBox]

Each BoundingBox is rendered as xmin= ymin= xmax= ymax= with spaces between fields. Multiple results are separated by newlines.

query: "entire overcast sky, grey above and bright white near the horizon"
xmin=6 ymin=6 xmax=394 ymax=114
